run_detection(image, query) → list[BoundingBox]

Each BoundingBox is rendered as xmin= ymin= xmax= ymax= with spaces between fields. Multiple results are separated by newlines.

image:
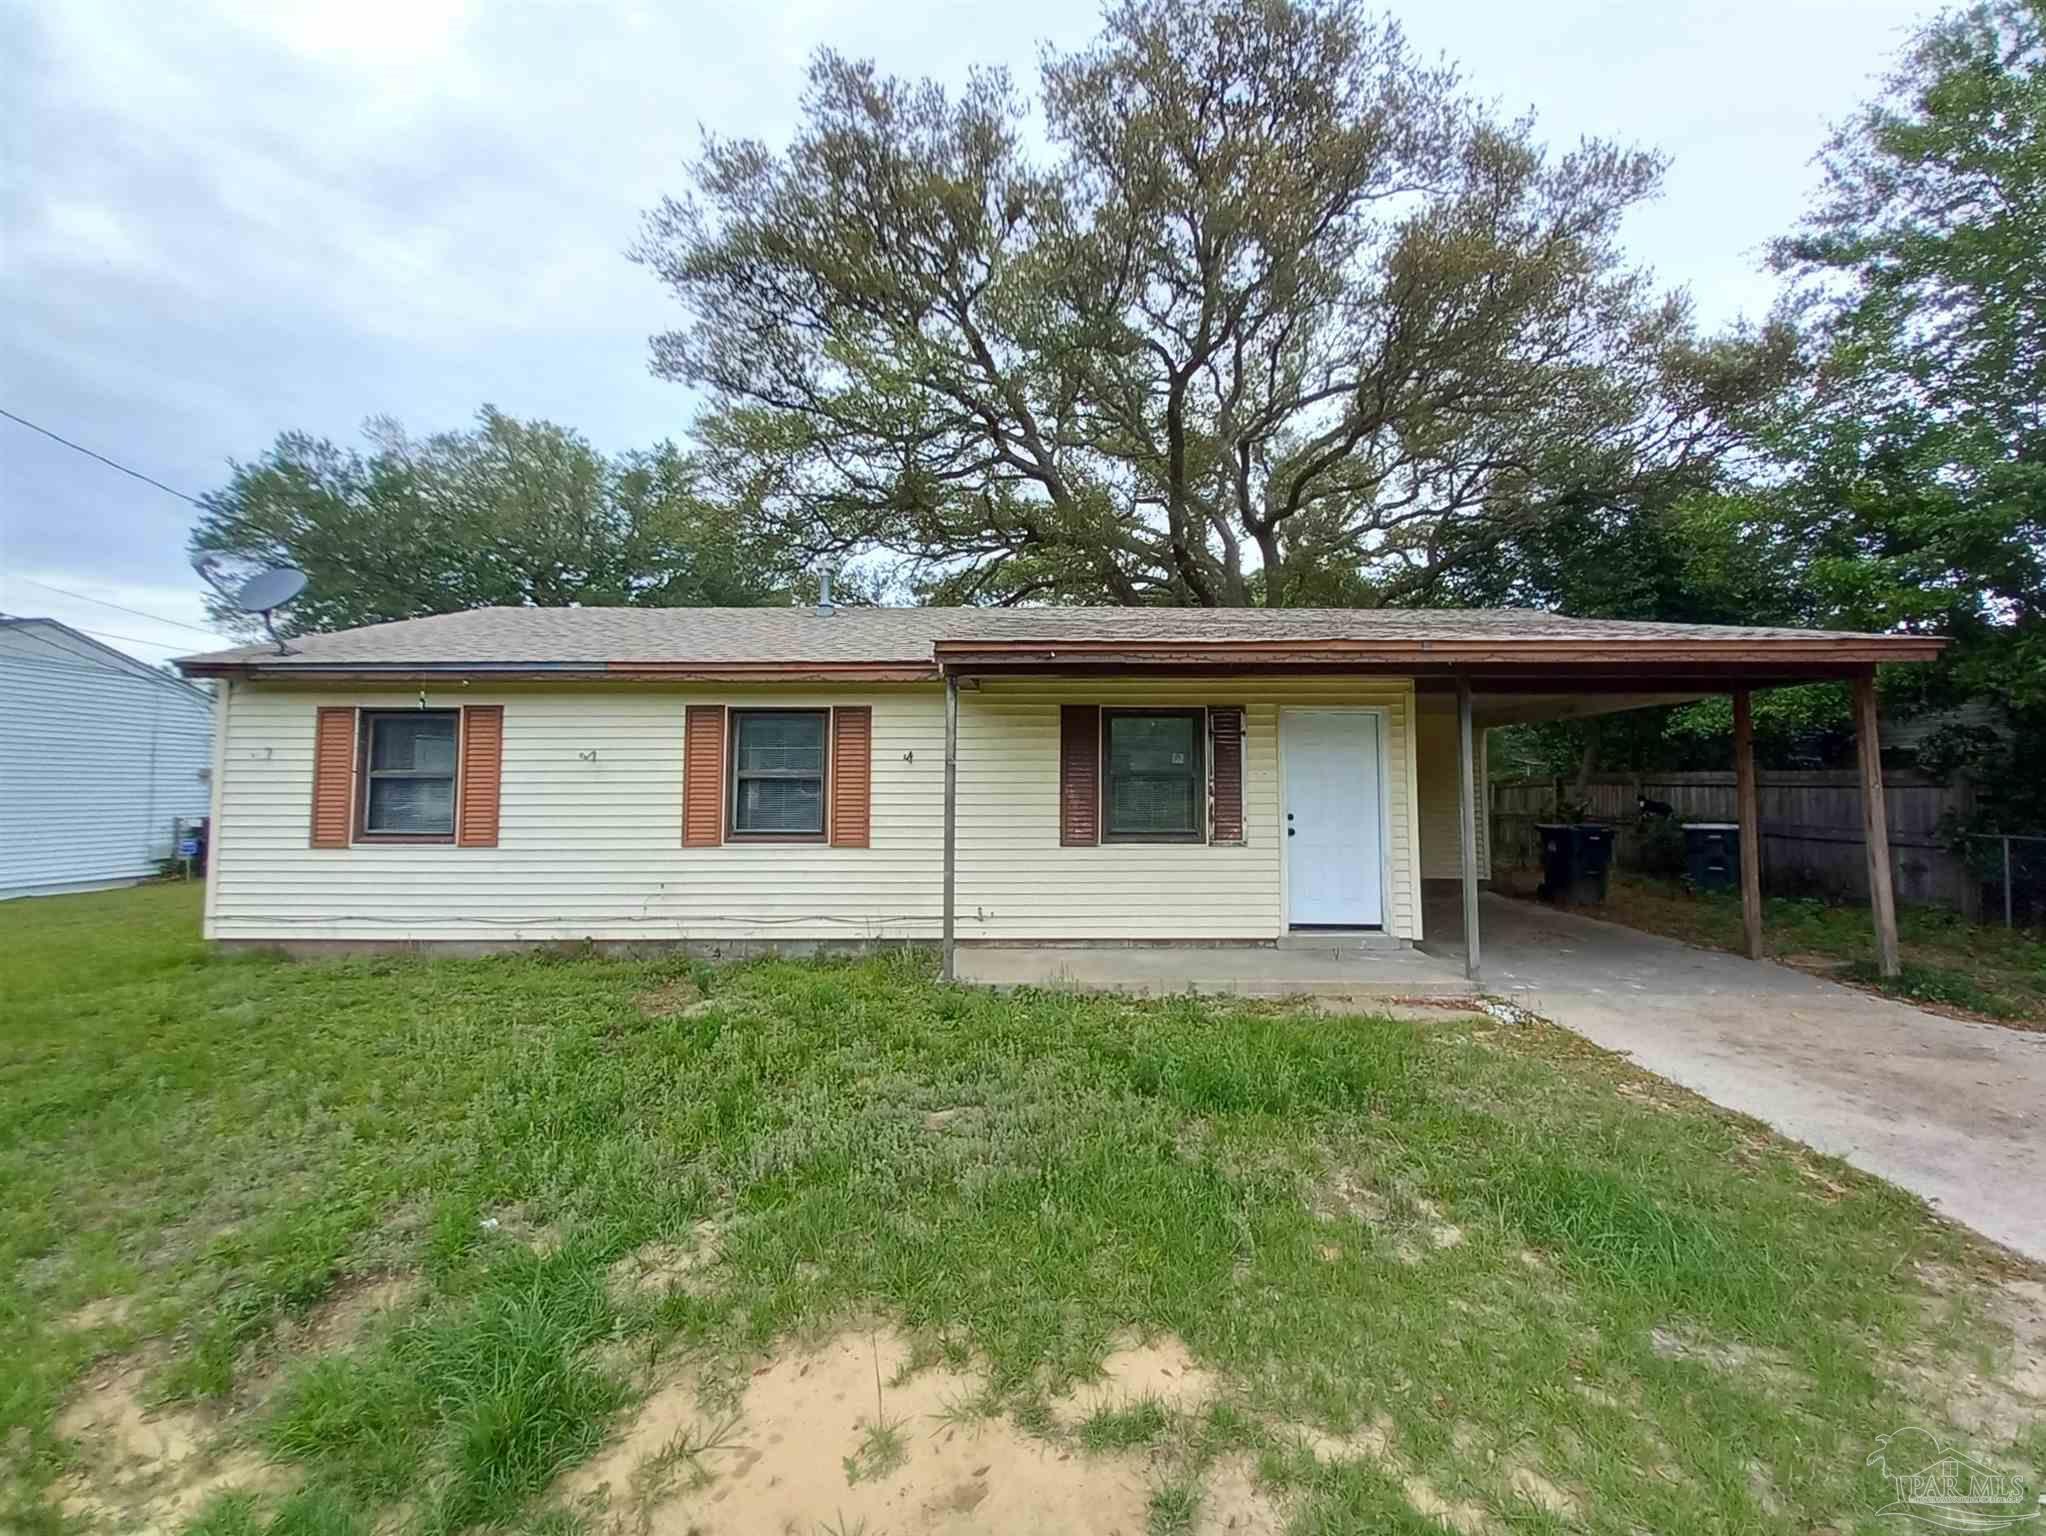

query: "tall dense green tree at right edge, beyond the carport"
xmin=1755 ymin=0 xmax=2046 ymax=824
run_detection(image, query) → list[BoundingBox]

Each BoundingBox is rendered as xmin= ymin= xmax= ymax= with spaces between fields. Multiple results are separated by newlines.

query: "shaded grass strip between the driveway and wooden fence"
xmin=1496 ymin=869 xmax=2046 ymax=1029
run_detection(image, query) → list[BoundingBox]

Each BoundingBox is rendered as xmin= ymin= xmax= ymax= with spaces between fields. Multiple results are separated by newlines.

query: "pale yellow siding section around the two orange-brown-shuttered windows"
xmin=209 ymin=687 xmax=945 ymax=941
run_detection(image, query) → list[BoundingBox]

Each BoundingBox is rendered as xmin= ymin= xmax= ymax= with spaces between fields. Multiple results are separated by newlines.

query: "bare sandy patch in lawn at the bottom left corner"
xmin=49 ymin=1364 xmax=288 ymax=1536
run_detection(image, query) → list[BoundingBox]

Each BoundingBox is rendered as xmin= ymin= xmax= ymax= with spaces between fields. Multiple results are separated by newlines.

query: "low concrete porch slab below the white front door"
xmin=958 ymin=945 xmax=1477 ymax=998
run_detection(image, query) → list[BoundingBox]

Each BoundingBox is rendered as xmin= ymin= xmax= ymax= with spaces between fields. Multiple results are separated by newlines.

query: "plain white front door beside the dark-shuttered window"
xmin=1279 ymin=710 xmax=1385 ymax=929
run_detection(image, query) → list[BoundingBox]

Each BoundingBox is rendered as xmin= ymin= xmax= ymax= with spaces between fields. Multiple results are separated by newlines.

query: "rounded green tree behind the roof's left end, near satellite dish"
xmin=190 ymin=407 xmax=800 ymax=630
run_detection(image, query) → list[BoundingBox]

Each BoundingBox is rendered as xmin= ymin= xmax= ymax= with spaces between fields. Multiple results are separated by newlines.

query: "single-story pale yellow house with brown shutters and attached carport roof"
xmin=180 ymin=607 xmax=1938 ymax=976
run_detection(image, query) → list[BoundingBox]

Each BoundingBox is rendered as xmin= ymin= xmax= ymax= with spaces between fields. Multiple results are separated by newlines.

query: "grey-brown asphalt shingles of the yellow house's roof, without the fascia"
xmin=180 ymin=607 xmax=1915 ymax=671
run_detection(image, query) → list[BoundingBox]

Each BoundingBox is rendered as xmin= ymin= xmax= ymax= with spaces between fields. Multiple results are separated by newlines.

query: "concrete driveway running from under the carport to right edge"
xmin=1424 ymin=896 xmax=2046 ymax=1260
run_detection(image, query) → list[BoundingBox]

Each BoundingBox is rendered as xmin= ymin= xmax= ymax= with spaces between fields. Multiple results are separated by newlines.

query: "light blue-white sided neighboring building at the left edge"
xmin=0 ymin=618 xmax=213 ymax=900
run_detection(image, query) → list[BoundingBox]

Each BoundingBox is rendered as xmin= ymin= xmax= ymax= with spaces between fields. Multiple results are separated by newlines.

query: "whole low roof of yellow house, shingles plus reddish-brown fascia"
xmin=178 ymin=607 xmax=1942 ymax=681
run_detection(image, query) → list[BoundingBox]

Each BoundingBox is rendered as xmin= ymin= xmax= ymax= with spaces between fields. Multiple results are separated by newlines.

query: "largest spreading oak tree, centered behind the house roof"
xmin=636 ymin=0 xmax=1794 ymax=605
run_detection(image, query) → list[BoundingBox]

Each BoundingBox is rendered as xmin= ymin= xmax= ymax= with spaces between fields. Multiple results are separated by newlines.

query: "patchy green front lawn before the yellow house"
xmin=0 ymin=886 xmax=2046 ymax=1536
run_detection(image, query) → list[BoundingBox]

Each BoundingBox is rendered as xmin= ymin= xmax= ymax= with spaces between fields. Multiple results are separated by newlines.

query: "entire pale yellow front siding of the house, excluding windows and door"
xmin=207 ymin=679 xmax=1420 ymax=941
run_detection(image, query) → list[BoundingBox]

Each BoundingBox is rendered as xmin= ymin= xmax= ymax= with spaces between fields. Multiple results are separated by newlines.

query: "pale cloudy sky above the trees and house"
xmin=0 ymin=0 xmax=1931 ymax=661
